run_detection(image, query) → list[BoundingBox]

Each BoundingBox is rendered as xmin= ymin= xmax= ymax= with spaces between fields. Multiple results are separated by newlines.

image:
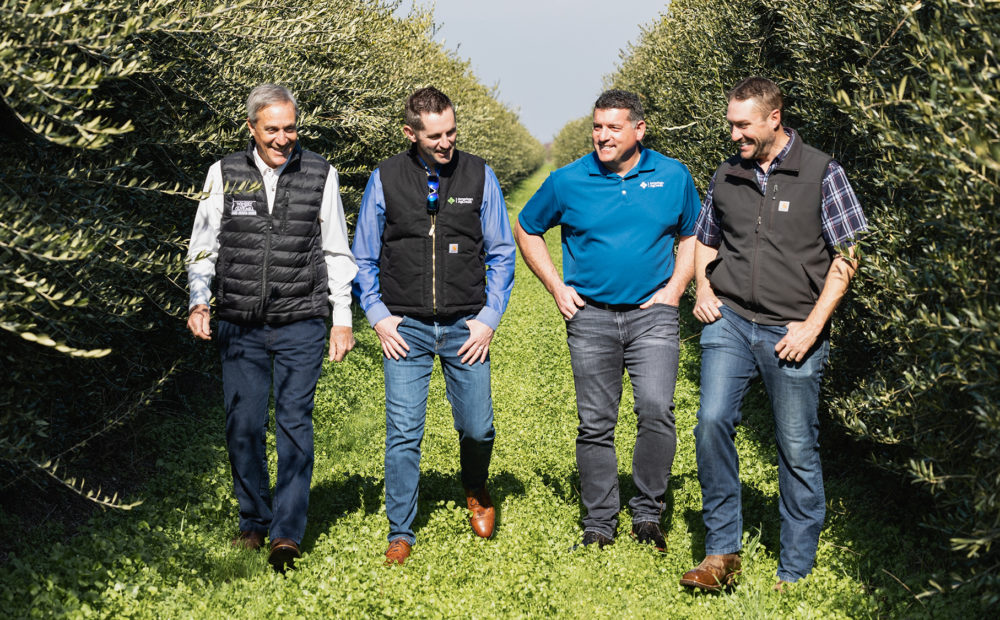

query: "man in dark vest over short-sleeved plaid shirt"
xmin=681 ymin=77 xmax=867 ymax=590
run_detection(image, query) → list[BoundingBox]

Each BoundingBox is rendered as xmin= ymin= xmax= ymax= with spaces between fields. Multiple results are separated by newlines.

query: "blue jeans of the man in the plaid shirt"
xmin=694 ymin=306 xmax=830 ymax=582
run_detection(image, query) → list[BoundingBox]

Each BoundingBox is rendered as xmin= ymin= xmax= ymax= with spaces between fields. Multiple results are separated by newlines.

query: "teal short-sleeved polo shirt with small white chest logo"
xmin=518 ymin=148 xmax=701 ymax=304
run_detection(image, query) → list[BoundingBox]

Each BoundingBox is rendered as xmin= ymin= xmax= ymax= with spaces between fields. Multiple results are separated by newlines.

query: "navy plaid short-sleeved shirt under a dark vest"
xmin=695 ymin=129 xmax=868 ymax=248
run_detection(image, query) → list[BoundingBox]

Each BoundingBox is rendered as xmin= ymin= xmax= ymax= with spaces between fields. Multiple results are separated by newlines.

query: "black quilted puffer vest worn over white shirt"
xmin=215 ymin=140 xmax=330 ymax=325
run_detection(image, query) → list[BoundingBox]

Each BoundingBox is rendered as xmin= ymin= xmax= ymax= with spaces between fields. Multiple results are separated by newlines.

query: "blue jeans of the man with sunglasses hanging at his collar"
xmin=382 ymin=316 xmax=495 ymax=545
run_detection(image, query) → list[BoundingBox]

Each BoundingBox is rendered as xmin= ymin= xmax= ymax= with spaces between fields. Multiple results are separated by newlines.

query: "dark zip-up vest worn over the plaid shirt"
xmin=706 ymin=130 xmax=833 ymax=325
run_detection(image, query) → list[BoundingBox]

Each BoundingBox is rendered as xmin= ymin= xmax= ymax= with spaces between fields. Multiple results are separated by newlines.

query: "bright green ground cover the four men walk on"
xmin=0 ymin=162 xmax=975 ymax=618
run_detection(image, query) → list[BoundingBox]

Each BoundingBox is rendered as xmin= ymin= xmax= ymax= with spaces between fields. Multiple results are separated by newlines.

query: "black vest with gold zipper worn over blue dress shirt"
xmin=379 ymin=148 xmax=486 ymax=317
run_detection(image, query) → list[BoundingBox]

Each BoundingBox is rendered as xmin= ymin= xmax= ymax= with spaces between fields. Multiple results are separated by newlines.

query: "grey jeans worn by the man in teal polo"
xmin=566 ymin=304 xmax=680 ymax=538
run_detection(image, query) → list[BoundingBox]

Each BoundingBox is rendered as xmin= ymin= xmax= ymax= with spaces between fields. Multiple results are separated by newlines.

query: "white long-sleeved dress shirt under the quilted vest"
xmin=187 ymin=149 xmax=358 ymax=327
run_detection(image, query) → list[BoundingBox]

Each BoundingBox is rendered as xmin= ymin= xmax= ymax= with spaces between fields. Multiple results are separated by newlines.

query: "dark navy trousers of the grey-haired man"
xmin=217 ymin=319 xmax=327 ymax=543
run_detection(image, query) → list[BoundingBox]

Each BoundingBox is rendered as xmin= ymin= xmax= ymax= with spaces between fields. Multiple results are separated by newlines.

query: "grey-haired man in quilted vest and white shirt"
xmin=188 ymin=84 xmax=357 ymax=571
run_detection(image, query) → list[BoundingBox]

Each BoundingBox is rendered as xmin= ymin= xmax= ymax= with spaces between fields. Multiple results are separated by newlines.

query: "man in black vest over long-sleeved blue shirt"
xmin=353 ymin=87 xmax=515 ymax=564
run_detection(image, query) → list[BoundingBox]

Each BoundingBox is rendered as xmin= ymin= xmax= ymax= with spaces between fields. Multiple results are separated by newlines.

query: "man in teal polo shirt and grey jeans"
xmin=514 ymin=90 xmax=700 ymax=551
